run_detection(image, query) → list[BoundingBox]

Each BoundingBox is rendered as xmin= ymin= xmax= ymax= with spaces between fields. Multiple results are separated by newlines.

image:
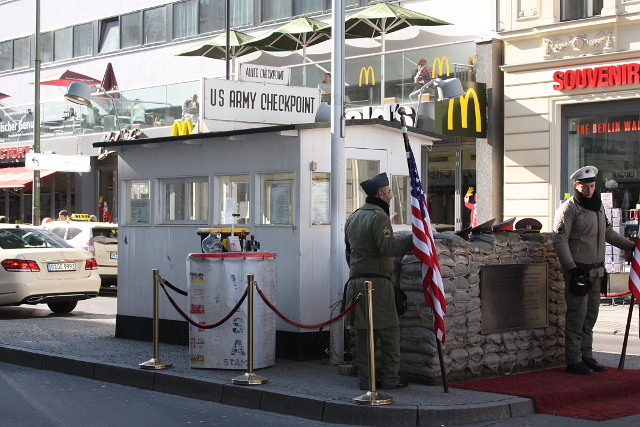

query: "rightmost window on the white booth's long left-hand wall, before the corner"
xmin=261 ymin=172 xmax=294 ymax=225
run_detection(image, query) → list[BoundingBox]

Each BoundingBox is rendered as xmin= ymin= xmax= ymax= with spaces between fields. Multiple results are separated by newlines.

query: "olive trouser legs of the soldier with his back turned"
xmin=356 ymin=327 xmax=400 ymax=388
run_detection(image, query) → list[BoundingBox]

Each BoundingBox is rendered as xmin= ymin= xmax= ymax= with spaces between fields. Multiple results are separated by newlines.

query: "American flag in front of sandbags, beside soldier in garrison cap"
xmin=402 ymin=137 xmax=444 ymax=344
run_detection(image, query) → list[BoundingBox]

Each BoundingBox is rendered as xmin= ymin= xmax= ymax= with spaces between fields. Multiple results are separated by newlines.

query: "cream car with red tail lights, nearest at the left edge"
xmin=0 ymin=224 xmax=100 ymax=313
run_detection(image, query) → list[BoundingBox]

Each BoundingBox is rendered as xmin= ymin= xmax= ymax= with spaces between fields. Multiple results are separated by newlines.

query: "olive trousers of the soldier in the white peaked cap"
xmin=564 ymin=276 xmax=604 ymax=365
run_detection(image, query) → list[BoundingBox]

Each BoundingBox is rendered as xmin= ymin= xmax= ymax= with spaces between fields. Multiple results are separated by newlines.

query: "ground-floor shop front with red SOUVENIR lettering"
xmin=503 ymin=42 xmax=640 ymax=292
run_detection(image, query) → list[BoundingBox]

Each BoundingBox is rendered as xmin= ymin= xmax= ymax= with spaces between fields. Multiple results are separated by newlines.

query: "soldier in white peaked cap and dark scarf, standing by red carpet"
xmin=552 ymin=166 xmax=634 ymax=375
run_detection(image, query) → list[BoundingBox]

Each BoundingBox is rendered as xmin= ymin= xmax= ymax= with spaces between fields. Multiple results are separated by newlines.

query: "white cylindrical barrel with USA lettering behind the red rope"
xmin=187 ymin=252 xmax=277 ymax=370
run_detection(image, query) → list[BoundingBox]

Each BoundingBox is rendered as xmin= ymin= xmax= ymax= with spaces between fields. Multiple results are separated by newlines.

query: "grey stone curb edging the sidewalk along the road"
xmin=0 ymin=345 xmax=535 ymax=426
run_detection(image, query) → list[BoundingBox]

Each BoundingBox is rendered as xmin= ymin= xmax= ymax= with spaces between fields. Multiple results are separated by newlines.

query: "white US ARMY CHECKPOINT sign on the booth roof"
xmin=203 ymin=78 xmax=320 ymax=124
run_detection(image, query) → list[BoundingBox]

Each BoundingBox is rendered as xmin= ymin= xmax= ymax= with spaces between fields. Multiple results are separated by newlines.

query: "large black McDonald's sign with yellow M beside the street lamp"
xmin=435 ymin=81 xmax=487 ymax=138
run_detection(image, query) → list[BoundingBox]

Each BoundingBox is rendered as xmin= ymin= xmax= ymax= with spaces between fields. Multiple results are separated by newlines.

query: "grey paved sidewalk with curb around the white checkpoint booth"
xmin=0 ymin=305 xmax=638 ymax=426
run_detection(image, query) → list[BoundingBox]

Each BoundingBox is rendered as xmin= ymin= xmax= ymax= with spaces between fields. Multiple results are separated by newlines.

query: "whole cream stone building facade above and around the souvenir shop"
xmin=498 ymin=0 xmax=640 ymax=288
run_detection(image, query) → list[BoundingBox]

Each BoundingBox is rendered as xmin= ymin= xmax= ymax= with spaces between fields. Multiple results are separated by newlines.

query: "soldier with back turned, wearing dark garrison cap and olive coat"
xmin=345 ymin=173 xmax=413 ymax=390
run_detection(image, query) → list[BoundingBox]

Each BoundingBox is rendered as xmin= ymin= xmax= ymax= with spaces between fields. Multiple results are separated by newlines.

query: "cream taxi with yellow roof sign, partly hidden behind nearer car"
xmin=42 ymin=214 xmax=118 ymax=286
